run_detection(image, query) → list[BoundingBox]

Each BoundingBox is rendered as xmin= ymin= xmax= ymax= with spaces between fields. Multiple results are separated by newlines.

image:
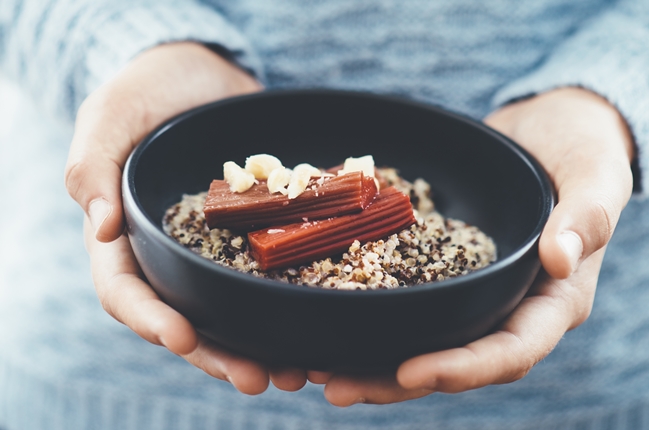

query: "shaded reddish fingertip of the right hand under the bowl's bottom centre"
xmin=324 ymin=374 xmax=433 ymax=407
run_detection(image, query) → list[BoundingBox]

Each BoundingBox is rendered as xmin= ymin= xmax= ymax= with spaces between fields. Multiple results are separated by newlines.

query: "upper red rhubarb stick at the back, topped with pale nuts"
xmin=203 ymin=172 xmax=378 ymax=231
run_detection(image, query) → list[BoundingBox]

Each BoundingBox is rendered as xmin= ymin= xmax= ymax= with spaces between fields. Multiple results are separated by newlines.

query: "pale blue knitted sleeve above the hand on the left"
xmin=0 ymin=0 xmax=262 ymax=118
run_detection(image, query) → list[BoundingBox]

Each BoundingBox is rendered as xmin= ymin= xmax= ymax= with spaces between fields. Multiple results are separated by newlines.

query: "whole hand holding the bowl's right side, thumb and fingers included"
xmin=308 ymin=88 xmax=634 ymax=406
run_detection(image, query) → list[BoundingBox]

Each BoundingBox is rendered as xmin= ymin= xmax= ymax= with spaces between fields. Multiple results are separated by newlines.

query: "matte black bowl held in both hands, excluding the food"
xmin=123 ymin=90 xmax=554 ymax=371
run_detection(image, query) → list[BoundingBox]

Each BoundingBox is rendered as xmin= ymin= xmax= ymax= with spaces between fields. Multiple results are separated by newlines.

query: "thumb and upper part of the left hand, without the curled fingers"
xmin=65 ymin=42 xmax=261 ymax=242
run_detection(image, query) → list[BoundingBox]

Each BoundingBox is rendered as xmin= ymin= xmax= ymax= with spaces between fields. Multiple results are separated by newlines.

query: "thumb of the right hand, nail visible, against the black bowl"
xmin=539 ymin=155 xmax=632 ymax=279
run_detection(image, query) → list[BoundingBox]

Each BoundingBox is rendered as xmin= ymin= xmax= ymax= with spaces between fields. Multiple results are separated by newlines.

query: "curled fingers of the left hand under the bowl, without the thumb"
xmin=84 ymin=219 xmax=276 ymax=395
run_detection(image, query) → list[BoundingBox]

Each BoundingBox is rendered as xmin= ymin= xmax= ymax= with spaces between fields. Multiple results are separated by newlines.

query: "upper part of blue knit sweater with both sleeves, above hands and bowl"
xmin=0 ymin=0 xmax=649 ymax=188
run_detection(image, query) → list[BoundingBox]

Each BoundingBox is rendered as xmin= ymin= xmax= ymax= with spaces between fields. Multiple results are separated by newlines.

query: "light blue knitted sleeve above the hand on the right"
xmin=493 ymin=0 xmax=649 ymax=194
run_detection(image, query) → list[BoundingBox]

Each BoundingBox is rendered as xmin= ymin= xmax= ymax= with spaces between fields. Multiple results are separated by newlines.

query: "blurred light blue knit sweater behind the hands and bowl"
xmin=0 ymin=0 xmax=649 ymax=430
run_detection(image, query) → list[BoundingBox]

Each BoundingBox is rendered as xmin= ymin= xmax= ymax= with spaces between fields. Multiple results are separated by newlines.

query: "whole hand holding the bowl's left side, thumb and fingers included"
xmin=65 ymin=43 xmax=306 ymax=394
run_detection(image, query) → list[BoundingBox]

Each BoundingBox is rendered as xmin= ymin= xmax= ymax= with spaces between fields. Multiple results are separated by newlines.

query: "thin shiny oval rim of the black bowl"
xmin=122 ymin=88 xmax=556 ymax=297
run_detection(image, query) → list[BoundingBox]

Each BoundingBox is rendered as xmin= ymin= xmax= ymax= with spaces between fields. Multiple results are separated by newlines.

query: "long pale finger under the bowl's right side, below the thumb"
xmin=397 ymin=250 xmax=604 ymax=393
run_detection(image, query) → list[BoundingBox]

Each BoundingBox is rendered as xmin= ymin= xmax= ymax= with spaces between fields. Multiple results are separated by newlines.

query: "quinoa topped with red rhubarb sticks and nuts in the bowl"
xmin=163 ymin=155 xmax=496 ymax=290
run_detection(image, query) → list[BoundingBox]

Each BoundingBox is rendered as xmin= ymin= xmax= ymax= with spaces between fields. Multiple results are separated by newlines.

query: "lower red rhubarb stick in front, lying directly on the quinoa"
xmin=248 ymin=187 xmax=416 ymax=270
